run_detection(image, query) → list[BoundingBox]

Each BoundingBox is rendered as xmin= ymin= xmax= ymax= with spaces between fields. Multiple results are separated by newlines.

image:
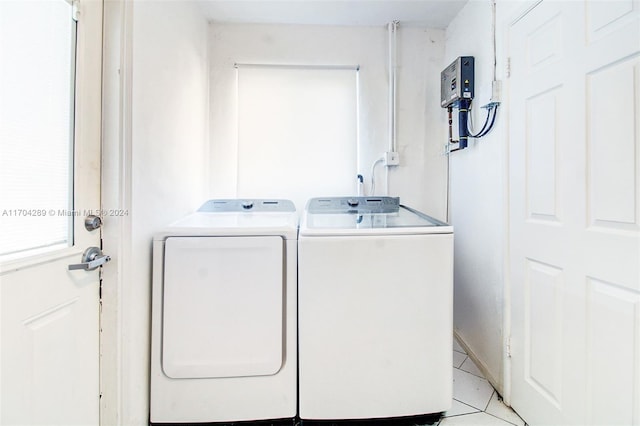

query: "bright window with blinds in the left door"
xmin=0 ymin=0 xmax=76 ymax=256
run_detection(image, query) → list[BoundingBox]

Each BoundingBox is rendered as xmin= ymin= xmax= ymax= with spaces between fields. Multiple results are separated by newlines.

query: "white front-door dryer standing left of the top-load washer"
xmin=150 ymin=200 xmax=298 ymax=423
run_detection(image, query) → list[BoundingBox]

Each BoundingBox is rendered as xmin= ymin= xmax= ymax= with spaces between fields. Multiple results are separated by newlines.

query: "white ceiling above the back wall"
xmin=199 ymin=0 xmax=468 ymax=29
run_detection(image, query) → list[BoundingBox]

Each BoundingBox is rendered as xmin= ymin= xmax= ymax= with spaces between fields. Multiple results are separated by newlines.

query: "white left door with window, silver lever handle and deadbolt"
xmin=0 ymin=0 xmax=102 ymax=425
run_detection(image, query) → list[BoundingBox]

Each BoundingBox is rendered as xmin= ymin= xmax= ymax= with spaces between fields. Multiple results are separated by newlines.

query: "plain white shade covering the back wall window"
xmin=237 ymin=65 xmax=358 ymax=210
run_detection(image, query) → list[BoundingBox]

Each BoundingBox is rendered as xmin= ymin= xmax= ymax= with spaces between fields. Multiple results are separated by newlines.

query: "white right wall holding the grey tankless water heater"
xmin=442 ymin=0 xmax=506 ymax=392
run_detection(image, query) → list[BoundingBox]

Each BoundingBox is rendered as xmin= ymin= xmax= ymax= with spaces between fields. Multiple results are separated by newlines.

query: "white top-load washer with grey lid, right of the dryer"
xmin=298 ymin=197 xmax=453 ymax=420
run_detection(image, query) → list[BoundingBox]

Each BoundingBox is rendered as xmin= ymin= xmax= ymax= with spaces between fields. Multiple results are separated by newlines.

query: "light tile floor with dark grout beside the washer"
xmin=430 ymin=339 xmax=526 ymax=426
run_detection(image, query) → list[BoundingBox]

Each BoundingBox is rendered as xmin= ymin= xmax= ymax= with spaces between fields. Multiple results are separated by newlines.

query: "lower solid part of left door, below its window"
xmin=1 ymin=262 xmax=99 ymax=425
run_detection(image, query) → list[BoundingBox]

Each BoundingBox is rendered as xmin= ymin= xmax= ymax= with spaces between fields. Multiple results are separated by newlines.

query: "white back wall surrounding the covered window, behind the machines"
xmin=209 ymin=23 xmax=446 ymax=219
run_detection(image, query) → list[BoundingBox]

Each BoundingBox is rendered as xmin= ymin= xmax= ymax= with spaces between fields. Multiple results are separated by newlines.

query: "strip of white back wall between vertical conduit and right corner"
xmin=389 ymin=23 xmax=447 ymax=221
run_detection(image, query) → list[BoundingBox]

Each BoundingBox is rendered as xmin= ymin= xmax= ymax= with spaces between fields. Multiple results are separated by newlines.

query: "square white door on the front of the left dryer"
xmin=162 ymin=236 xmax=284 ymax=378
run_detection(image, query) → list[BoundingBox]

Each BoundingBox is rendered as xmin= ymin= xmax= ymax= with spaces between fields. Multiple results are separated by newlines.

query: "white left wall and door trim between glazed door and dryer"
xmin=103 ymin=1 xmax=209 ymax=425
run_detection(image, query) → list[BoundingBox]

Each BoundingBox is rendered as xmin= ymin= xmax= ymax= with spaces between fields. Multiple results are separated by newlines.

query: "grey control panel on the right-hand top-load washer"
xmin=307 ymin=197 xmax=400 ymax=214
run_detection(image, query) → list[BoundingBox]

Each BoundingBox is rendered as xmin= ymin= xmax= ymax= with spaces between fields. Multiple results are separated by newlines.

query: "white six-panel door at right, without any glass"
xmin=508 ymin=0 xmax=640 ymax=425
